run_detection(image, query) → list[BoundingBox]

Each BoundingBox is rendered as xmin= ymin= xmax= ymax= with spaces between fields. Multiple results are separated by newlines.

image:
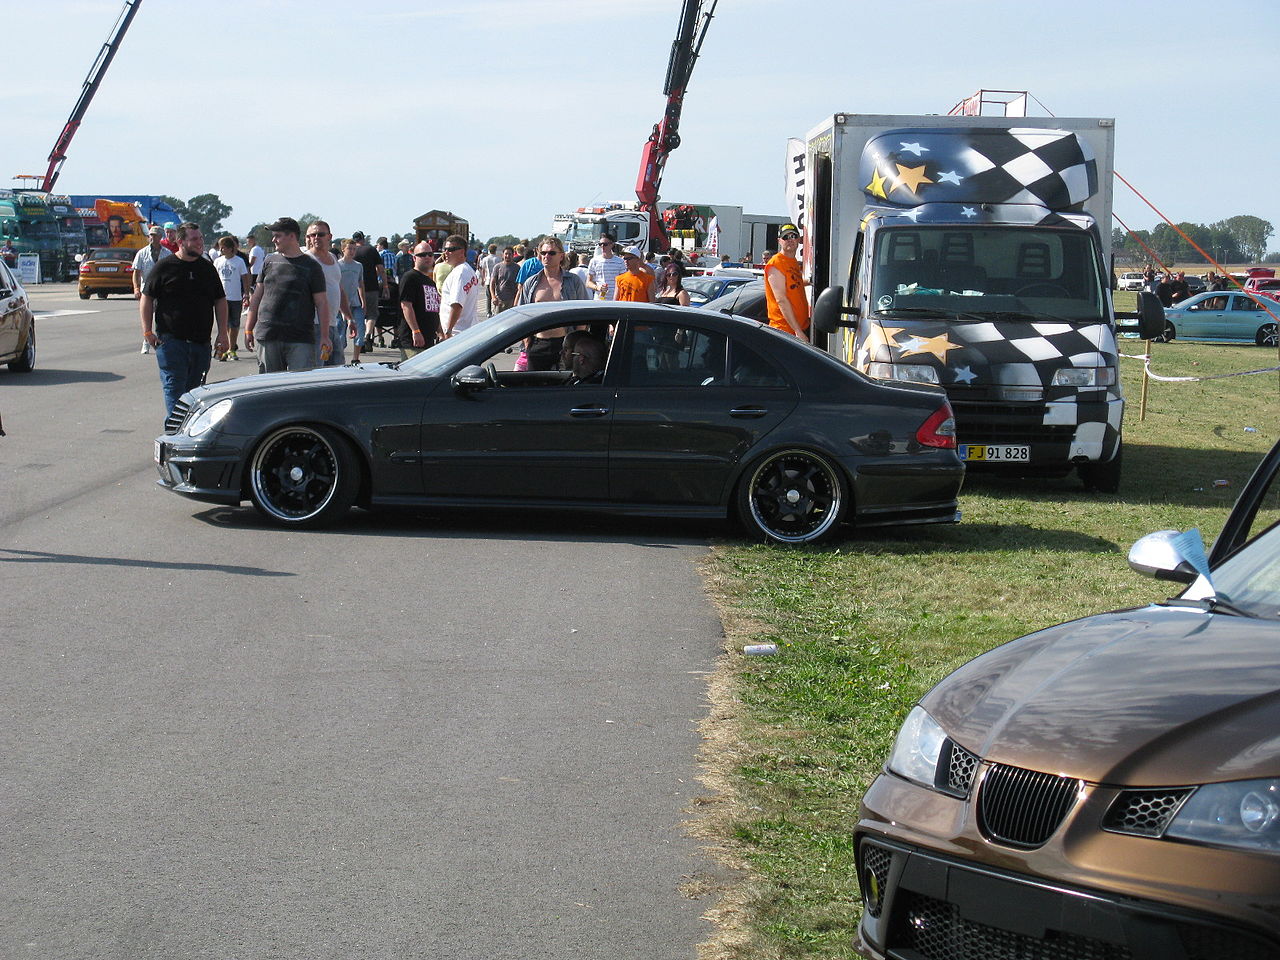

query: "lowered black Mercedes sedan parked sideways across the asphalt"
xmin=155 ymin=301 xmax=964 ymax=544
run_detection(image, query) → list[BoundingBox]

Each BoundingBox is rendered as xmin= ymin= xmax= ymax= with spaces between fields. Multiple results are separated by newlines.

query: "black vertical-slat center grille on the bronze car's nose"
xmin=978 ymin=763 xmax=1080 ymax=849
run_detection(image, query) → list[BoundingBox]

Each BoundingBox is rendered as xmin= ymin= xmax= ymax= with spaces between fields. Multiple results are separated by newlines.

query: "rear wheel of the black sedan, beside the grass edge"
xmin=736 ymin=449 xmax=849 ymax=544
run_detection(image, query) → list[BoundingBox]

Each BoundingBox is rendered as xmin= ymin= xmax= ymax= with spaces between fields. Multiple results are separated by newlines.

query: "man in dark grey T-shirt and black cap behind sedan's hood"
xmin=244 ymin=216 xmax=333 ymax=374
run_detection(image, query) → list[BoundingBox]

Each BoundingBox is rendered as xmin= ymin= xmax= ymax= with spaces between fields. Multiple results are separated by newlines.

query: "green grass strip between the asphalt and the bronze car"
xmin=692 ymin=332 xmax=1280 ymax=960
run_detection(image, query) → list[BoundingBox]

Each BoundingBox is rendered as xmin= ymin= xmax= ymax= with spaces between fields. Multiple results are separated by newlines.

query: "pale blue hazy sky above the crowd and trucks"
xmin=10 ymin=0 xmax=1280 ymax=256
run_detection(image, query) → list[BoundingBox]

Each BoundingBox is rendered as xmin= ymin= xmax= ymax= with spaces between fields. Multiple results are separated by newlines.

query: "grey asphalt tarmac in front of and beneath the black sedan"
xmin=0 ymin=287 xmax=722 ymax=960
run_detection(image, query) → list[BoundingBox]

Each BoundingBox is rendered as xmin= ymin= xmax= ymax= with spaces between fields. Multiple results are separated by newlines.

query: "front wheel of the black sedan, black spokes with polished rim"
xmin=248 ymin=426 xmax=360 ymax=527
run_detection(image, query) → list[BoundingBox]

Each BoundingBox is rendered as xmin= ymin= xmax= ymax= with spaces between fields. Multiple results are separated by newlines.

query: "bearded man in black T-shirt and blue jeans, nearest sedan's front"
xmin=138 ymin=223 xmax=227 ymax=416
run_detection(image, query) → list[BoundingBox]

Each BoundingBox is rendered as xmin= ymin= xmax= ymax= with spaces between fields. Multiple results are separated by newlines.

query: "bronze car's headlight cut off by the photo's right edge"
xmin=1165 ymin=780 xmax=1280 ymax=852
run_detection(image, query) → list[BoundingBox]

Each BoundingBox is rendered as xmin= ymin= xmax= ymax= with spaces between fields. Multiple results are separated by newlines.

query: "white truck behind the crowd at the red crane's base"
xmin=552 ymin=200 xmax=787 ymax=260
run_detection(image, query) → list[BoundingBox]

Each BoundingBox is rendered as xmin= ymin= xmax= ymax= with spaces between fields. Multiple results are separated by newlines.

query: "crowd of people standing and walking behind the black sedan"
xmin=133 ymin=216 xmax=809 ymax=416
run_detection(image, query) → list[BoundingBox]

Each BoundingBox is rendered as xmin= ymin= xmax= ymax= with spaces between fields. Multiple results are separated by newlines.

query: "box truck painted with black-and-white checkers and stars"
xmin=787 ymin=114 xmax=1146 ymax=492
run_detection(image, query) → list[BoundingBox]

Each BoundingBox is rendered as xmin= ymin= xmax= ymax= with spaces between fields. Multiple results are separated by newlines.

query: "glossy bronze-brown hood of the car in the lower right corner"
xmin=922 ymin=607 xmax=1280 ymax=786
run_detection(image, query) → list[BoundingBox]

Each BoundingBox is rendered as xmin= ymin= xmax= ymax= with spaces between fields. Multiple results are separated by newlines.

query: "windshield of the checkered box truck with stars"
xmin=870 ymin=225 xmax=1107 ymax=323
